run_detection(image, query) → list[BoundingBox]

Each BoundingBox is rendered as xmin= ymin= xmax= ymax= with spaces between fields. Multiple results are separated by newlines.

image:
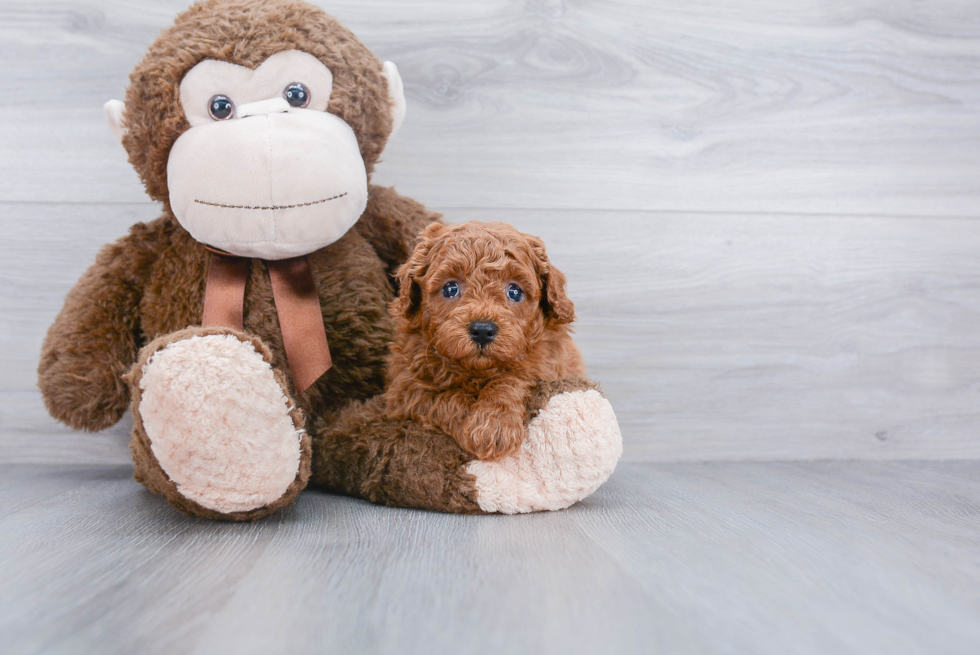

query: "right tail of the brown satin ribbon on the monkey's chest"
xmin=266 ymin=256 xmax=333 ymax=394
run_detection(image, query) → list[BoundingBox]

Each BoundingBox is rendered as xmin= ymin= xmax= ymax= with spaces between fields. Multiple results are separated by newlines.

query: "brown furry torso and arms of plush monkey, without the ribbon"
xmin=38 ymin=187 xmax=438 ymax=430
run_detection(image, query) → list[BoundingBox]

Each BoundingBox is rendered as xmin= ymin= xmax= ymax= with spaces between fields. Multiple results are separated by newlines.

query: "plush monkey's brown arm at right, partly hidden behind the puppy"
xmin=355 ymin=185 xmax=442 ymax=275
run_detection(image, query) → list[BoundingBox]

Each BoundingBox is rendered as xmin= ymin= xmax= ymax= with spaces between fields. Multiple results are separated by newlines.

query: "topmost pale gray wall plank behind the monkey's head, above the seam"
xmin=0 ymin=0 xmax=980 ymax=216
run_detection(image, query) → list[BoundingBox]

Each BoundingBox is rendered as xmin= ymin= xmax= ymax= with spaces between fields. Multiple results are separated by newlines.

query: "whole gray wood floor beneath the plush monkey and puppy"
xmin=0 ymin=462 xmax=980 ymax=655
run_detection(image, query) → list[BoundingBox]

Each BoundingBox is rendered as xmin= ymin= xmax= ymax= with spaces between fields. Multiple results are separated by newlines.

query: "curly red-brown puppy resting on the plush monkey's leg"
xmin=385 ymin=221 xmax=585 ymax=460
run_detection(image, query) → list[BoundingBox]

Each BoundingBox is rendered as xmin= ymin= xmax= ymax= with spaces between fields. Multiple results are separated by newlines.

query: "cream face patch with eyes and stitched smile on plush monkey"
xmin=167 ymin=50 xmax=367 ymax=259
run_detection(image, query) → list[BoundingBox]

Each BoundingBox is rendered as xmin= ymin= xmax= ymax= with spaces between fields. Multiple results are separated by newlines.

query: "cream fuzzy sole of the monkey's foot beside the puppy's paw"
xmin=466 ymin=389 xmax=623 ymax=514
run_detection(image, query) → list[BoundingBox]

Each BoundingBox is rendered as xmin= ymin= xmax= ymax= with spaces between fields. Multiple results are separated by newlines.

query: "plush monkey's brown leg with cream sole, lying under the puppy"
xmin=311 ymin=379 xmax=623 ymax=514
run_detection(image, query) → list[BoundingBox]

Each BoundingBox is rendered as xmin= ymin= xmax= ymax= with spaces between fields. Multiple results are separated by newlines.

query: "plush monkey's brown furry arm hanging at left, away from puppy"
xmin=37 ymin=224 xmax=154 ymax=431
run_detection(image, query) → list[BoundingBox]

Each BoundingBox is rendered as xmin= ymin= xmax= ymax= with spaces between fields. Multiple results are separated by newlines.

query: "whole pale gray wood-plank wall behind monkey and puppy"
xmin=0 ymin=0 xmax=980 ymax=462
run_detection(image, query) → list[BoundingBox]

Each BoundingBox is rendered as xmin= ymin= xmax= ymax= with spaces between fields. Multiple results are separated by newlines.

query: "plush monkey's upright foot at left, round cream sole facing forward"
xmin=126 ymin=327 xmax=311 ymax=521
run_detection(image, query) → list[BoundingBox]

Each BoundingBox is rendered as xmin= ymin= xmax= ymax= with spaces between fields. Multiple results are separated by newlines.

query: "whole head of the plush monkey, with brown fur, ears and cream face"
xmin=100 ymin=0 xmax=405 ymax=259
